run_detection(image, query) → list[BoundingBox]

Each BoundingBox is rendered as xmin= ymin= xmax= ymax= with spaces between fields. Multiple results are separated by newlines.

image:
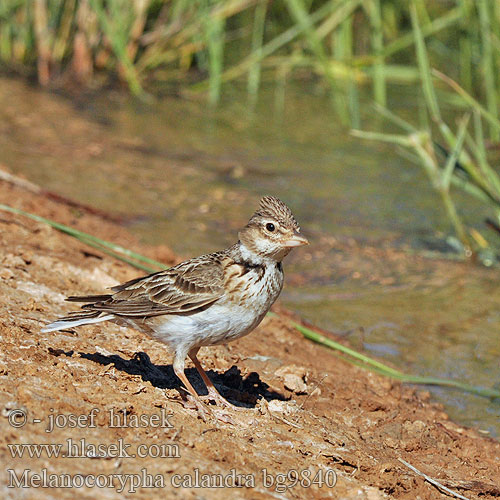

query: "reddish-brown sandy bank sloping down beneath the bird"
xmin=0 ymin=178 xmax=500 ymax=500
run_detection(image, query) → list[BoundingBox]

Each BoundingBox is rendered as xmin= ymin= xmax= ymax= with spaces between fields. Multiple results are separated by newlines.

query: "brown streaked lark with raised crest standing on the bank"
xmin=42 ymin=196 xmax=309 ymax=418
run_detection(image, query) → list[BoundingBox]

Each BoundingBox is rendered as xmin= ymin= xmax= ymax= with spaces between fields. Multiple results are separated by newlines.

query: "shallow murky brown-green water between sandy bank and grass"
xmin=0 ymin=79 xmax=500 ymax=435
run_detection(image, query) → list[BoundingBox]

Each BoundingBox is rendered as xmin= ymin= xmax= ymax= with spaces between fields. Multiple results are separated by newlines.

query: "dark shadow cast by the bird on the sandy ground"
xmin=60 ymin=352 xmax=287 ymax=408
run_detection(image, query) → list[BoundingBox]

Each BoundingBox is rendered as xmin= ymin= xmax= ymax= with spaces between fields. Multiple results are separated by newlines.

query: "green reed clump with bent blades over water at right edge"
xmin=353 ymin=0 xmax=500 ymax=254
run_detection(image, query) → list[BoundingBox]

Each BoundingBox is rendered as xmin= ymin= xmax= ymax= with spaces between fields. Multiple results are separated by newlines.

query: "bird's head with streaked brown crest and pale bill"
xmin=239 ymin=196 xmax=309 ymax=262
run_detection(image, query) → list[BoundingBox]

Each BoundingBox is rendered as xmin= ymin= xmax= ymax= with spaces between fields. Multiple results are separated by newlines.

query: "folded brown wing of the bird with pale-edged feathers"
xmin=83 ymin=254 xmax=224 ymax=317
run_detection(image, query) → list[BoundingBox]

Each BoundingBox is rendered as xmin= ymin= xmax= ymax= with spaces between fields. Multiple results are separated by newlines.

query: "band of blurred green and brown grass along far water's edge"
xmin=0 ymin=0 xmax=500 ymax=127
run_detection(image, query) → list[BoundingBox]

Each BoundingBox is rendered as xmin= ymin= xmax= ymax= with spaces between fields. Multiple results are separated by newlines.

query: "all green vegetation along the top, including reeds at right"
xmin=0 ymin=0 xmax=500 ymax=256
